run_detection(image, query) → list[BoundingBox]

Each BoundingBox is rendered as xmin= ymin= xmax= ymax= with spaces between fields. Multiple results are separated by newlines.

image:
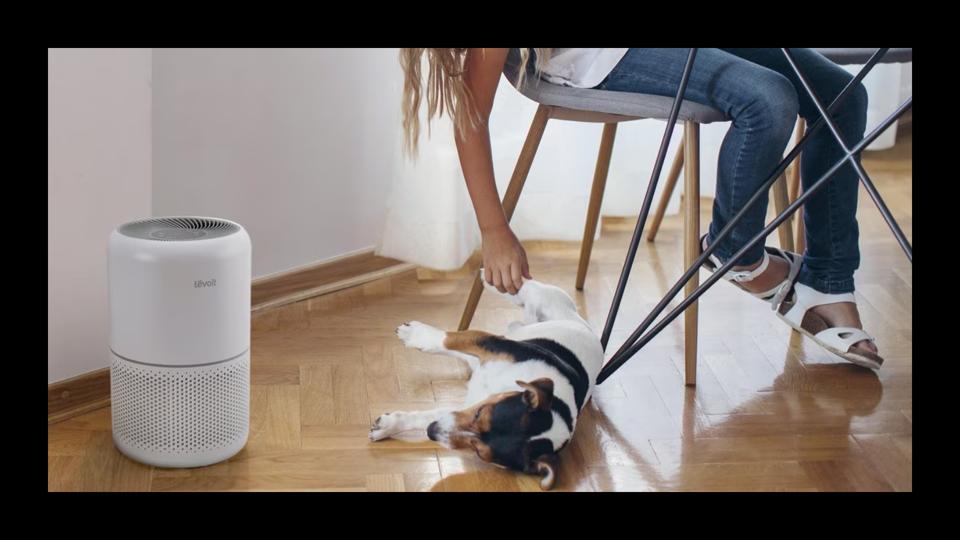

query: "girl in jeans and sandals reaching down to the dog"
xmin=400 ymin=48 xmax=883 ymax=369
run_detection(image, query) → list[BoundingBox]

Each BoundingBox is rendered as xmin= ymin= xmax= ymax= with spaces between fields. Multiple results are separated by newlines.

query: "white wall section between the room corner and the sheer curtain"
xmin=153 ymin=49 xmax=402 ymax=277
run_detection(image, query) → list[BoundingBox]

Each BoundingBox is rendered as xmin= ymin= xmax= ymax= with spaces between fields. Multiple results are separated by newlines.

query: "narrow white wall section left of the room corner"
xmin=47 ymin=49 xmax=151 ymax=383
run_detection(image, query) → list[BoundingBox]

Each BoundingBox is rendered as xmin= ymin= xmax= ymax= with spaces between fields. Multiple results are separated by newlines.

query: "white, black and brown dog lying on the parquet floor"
xmin=370 ymin=269 xmax=603 ymax=490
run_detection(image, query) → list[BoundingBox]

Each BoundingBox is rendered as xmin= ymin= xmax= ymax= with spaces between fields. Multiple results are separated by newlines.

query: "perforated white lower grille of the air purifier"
xmin=110 ymin=355 xmax=250 ymax=455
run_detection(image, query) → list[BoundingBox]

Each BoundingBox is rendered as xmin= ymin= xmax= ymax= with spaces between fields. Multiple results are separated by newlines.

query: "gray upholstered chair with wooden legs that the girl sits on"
xmin=459 ymin=50 xmax=728 ymax=384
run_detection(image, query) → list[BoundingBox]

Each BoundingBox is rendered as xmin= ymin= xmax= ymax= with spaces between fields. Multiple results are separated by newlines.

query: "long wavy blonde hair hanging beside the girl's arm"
xmin=400 ymin=48 xmax=551 ymax=157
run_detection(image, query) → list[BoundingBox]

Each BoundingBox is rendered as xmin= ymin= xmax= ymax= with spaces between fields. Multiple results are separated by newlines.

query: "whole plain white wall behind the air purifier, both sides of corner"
xmin=47 ymin=49 xmax=402 ymax=383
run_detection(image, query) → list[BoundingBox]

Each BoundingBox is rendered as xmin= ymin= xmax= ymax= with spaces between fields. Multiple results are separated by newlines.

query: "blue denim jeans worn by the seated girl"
xmin=596 ymin=49 xmax=867 ymax=294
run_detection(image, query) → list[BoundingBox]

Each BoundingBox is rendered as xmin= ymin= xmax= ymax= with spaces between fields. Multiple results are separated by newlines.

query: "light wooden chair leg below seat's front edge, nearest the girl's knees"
xmin=683 ymin=120 xmax=700 ymax=386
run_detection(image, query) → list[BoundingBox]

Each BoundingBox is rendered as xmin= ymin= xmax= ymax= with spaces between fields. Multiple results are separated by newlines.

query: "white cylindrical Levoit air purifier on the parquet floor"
xmin=108 ymin=217 xmax=251 ymax=467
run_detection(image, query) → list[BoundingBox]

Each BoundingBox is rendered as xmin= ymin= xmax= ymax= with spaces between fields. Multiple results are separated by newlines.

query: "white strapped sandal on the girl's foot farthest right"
xmin=777 ymin=283 xmax=883 ymax=369
